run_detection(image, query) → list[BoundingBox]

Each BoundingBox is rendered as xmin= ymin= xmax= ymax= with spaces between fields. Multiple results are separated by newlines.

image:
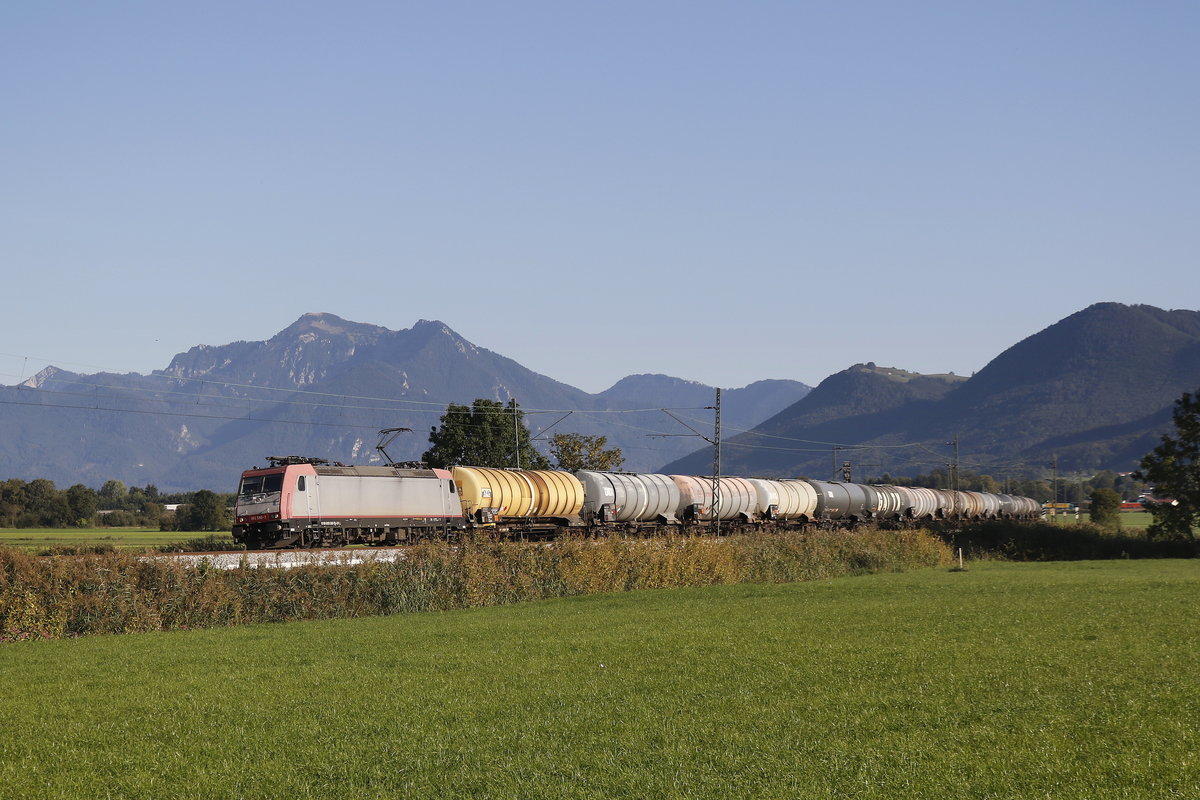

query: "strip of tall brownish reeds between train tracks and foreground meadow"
xmin=0 ymin=530 xmax=950 ymax=642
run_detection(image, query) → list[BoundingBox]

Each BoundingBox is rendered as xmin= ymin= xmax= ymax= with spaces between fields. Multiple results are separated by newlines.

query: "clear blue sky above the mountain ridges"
xmin=0 ymin=1 xmax=1200 ymax=391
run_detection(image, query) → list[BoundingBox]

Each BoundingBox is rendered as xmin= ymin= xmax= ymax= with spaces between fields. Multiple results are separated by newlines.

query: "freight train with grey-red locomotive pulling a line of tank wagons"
xmin=233 ymin=456 xmax=1042 ymax=551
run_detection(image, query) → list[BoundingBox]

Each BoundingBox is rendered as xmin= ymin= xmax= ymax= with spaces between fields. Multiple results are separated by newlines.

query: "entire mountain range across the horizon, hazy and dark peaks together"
xmin=0 ymin=302 xmax=1200 ymax=491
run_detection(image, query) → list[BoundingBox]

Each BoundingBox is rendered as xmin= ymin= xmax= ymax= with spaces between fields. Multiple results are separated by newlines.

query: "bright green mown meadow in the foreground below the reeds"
xmin=0 ymin=560 xmax=1200 ymax=800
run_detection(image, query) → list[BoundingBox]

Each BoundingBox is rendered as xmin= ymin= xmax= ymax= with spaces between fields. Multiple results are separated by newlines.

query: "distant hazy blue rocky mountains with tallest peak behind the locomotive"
xmin=0 ymin=313 xmax=810 ymax=491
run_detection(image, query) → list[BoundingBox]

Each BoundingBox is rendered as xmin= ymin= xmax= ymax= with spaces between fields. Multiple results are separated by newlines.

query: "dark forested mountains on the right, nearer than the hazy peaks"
xmin=664 ymin=302 xmax=1200 ymax=477
